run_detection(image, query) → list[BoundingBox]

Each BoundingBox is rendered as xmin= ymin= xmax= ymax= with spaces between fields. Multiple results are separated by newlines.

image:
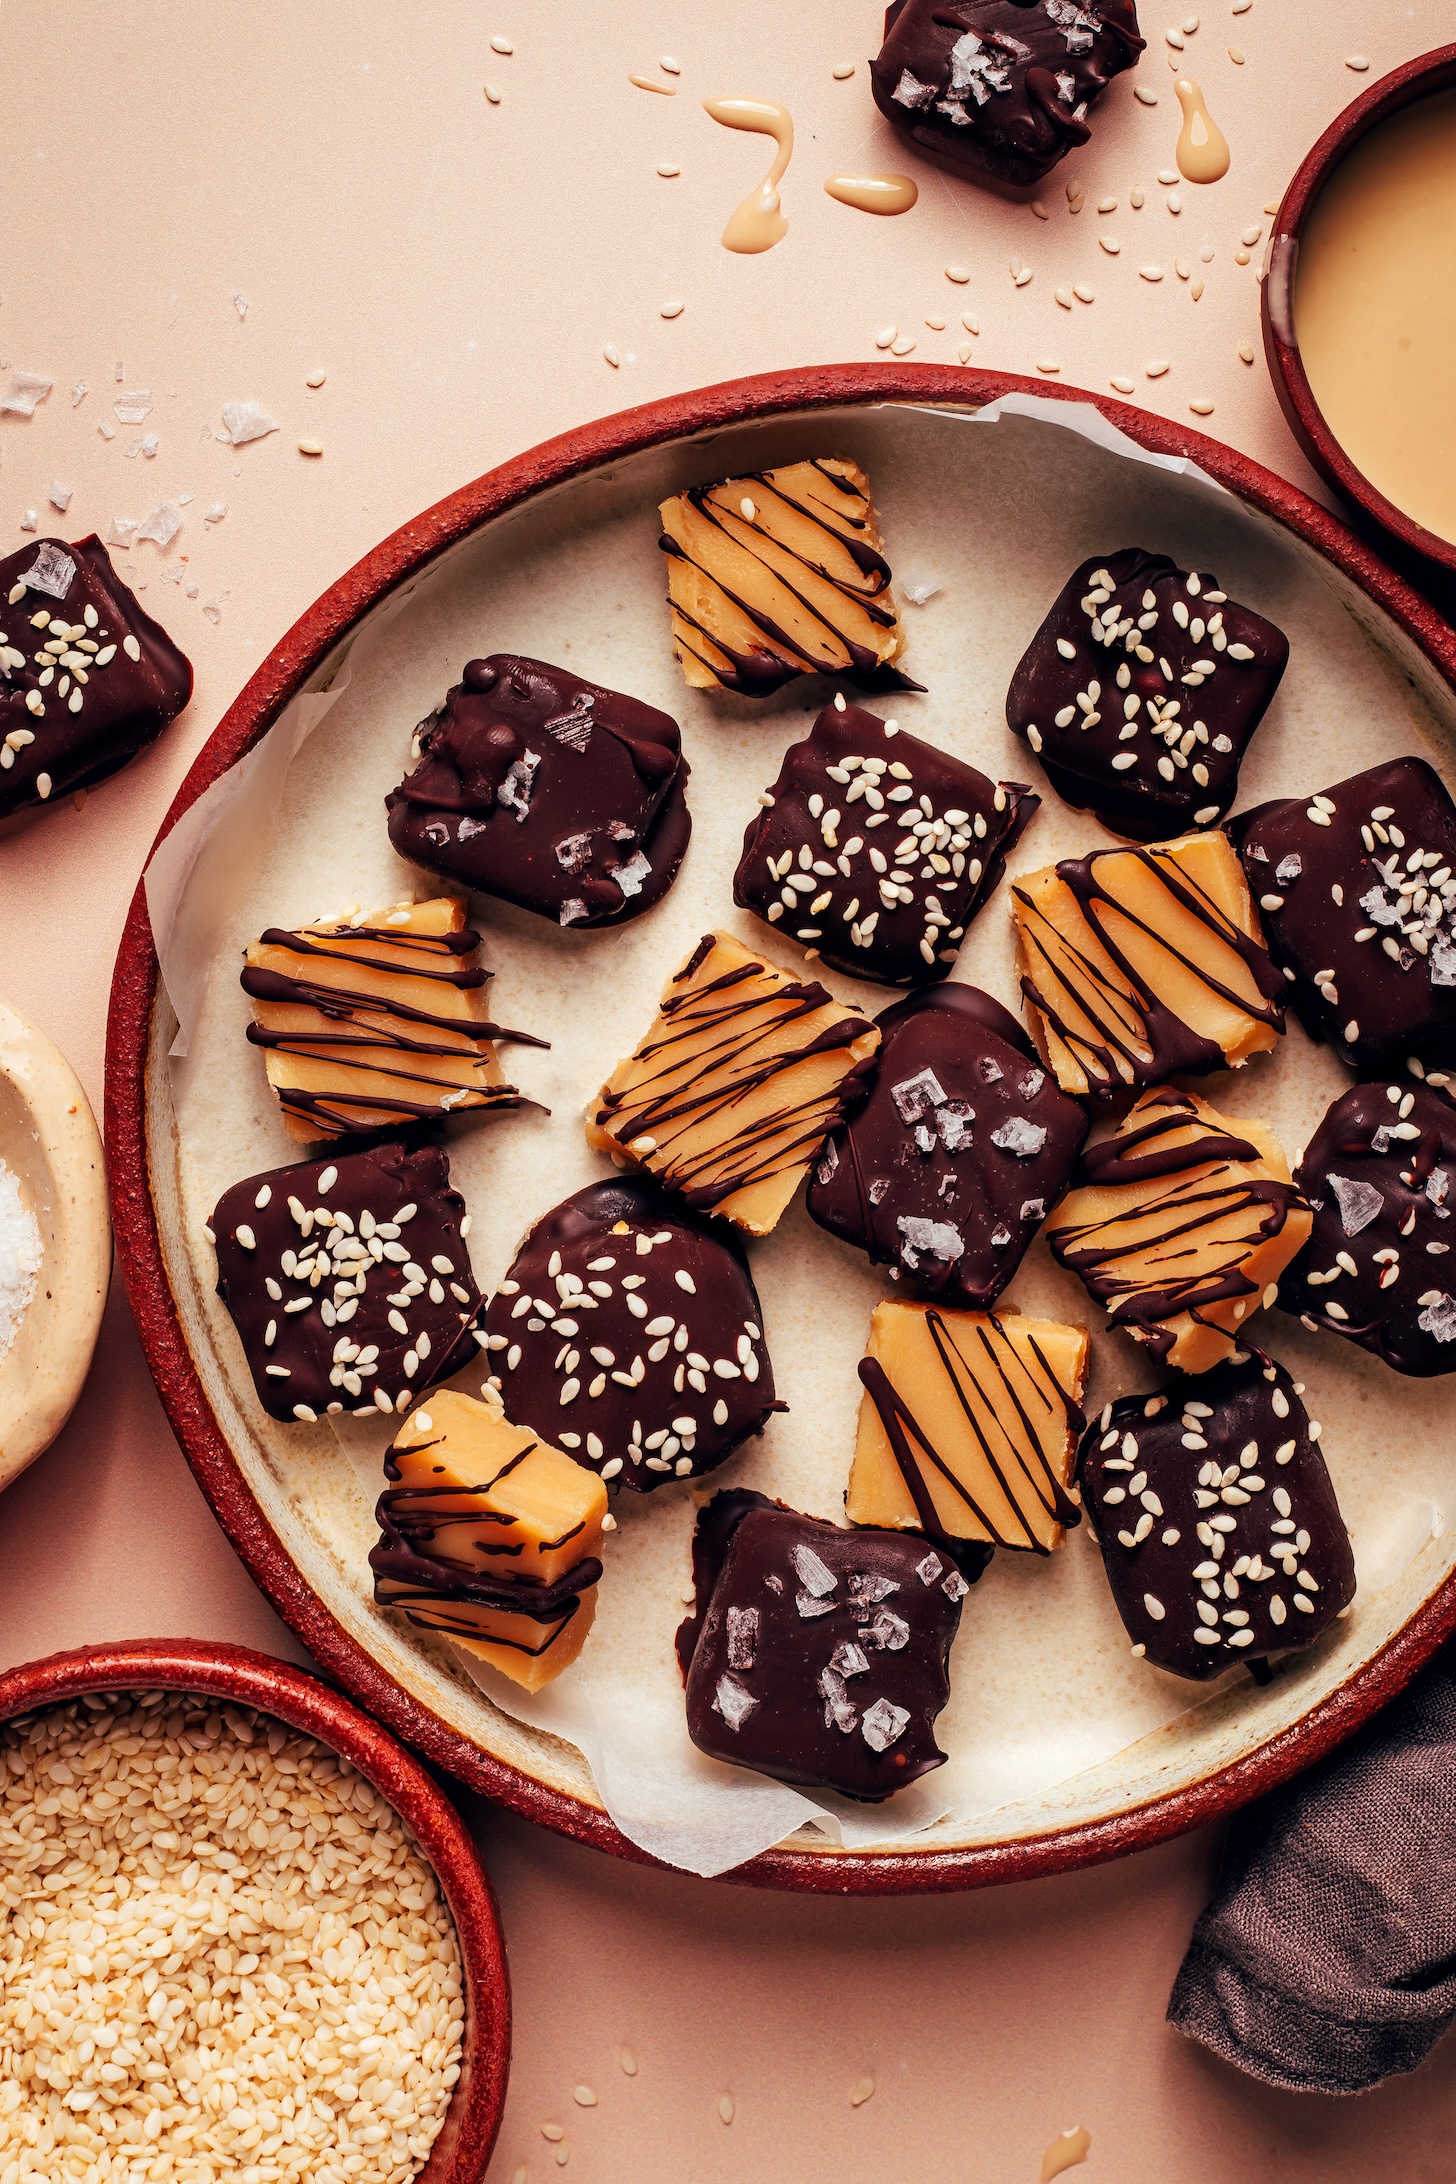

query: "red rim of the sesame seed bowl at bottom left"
xmin=0 ymin=1638 xmax=511 ymax=2184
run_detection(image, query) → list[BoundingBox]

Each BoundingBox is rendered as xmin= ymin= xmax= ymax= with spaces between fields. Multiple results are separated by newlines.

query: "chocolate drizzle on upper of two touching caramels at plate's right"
xmin=1013 ymin=845 xmax=1284 ymax=1096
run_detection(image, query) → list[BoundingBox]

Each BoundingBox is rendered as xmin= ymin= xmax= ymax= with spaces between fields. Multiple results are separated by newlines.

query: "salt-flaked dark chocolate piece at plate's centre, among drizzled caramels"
xmin=808 ymin=985 xmax=1087 ymax=1313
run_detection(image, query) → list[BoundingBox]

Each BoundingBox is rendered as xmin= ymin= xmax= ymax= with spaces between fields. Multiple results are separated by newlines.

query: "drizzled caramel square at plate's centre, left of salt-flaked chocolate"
xmin=587 ymin=933 xmax=880 ymax=1236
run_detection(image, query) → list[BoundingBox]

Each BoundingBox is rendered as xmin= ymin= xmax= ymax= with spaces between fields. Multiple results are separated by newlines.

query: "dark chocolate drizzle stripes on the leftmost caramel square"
xmin=240 ymin=924 xmax=548 ymax=1138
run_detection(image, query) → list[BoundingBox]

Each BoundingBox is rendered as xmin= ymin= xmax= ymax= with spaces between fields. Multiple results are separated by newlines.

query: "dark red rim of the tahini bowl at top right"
xmin=1262 ymin=46 xmax=1456 ymax=612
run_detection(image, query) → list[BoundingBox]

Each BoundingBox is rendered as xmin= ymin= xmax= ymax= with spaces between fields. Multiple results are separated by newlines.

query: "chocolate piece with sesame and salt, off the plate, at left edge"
xmin=0 ymin=535 xmax=192 ymax=819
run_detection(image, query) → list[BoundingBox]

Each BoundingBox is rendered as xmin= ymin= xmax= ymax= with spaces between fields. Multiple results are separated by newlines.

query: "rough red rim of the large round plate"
xmin=105 ymin=363 xmax=1456 ymax=1896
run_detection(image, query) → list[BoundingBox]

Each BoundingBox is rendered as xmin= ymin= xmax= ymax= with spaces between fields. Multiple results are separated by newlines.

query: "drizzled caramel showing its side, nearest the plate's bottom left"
xmin=369 ymin=1389 xmax=607 ymax=1690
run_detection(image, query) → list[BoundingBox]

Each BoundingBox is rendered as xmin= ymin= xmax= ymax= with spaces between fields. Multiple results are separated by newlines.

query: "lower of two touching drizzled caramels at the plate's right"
xmin=1046 ymin=1085 xmax=1310 ymax=1372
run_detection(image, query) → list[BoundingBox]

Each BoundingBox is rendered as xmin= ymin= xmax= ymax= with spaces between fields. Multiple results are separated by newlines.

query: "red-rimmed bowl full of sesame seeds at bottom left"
xmin=0 ymin=1640 xmax=511 ymax=2184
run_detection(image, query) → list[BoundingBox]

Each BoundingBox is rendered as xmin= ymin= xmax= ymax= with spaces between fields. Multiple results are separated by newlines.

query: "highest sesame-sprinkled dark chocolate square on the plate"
xmin=1006 ymin=546 xmax=1290 ymax=841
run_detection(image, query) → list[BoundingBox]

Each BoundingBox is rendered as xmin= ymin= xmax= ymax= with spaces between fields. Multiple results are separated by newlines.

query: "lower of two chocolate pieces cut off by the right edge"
xmin=1279 ymin=1083 xmax=1456 ymax=1380
